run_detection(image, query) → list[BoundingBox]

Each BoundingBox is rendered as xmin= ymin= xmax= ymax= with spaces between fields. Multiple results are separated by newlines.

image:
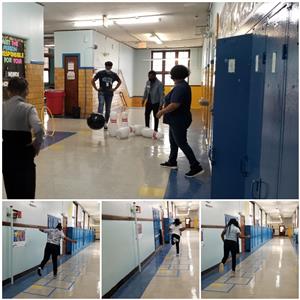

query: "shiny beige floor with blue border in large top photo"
xmin=15 ymin=108 xmax=210 ymax=199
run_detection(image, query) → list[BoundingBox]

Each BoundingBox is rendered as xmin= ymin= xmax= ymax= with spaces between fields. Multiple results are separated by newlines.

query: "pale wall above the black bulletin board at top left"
xmin=2 ymin=2 xmax=44 ymax=63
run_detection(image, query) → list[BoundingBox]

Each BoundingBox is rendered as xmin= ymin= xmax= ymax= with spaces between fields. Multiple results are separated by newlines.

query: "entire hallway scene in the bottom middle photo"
xmin=102 ymin=200 xmax=200 ymax=299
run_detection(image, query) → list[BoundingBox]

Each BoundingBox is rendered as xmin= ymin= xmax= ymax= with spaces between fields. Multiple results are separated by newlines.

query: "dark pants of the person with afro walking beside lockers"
xmin=169 ymin=125 xmax=200 ymax=169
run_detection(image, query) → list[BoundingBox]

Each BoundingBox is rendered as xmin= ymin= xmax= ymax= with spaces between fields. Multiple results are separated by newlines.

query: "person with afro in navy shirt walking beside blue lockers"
xmin=156 ymin=65 xmax=204 ymax=177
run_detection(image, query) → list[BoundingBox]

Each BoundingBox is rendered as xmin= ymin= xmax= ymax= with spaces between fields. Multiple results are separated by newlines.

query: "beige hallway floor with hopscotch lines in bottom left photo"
xmin=15 ymin=242 xmax=100 ymax=299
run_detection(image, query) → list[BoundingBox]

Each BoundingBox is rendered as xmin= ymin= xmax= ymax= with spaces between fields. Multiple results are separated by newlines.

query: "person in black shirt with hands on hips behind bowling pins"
xmin=92 ymin=61 xmax=122 ymax=130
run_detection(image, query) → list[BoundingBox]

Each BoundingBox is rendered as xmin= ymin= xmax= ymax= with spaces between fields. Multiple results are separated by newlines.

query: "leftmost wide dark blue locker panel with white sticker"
xmin=211 ymin=35 xmax=252 ymax=198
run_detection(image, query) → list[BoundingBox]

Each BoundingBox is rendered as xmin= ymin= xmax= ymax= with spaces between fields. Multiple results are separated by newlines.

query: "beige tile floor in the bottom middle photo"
xmin=142 ymin=230 xmax=199 ymax=299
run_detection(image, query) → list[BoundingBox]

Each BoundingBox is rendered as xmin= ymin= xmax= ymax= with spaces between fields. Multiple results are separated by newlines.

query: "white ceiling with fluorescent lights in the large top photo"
xmin=42 ymin=2 xmax=210 ymax=49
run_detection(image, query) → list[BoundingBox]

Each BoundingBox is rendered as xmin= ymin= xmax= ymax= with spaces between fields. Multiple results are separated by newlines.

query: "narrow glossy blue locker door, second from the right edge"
xmin=256 ymin=7 xmax=288 ymax=198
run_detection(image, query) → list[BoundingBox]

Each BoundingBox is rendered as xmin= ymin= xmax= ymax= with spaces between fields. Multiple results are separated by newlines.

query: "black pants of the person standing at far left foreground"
xmin=3 ymin=163 xmax=36 ymax=199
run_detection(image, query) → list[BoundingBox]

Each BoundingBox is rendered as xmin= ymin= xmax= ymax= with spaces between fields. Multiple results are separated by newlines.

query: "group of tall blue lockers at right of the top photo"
xmin=211 ymin=3 xmax=299 ymax=199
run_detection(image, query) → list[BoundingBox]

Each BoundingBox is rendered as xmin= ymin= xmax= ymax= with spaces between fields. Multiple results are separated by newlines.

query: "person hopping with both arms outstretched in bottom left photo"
xmin=37 ymin=223 xmax=77 ymax=277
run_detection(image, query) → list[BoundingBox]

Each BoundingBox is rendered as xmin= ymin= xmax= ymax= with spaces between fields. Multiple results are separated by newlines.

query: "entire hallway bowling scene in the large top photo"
xmin=2 ymin=2 xmax=299 ymax=199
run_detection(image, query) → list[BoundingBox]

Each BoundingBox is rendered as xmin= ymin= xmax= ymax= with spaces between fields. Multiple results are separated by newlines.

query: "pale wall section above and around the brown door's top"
xmin=54 ymin=30 xmax=95 ymax=68
